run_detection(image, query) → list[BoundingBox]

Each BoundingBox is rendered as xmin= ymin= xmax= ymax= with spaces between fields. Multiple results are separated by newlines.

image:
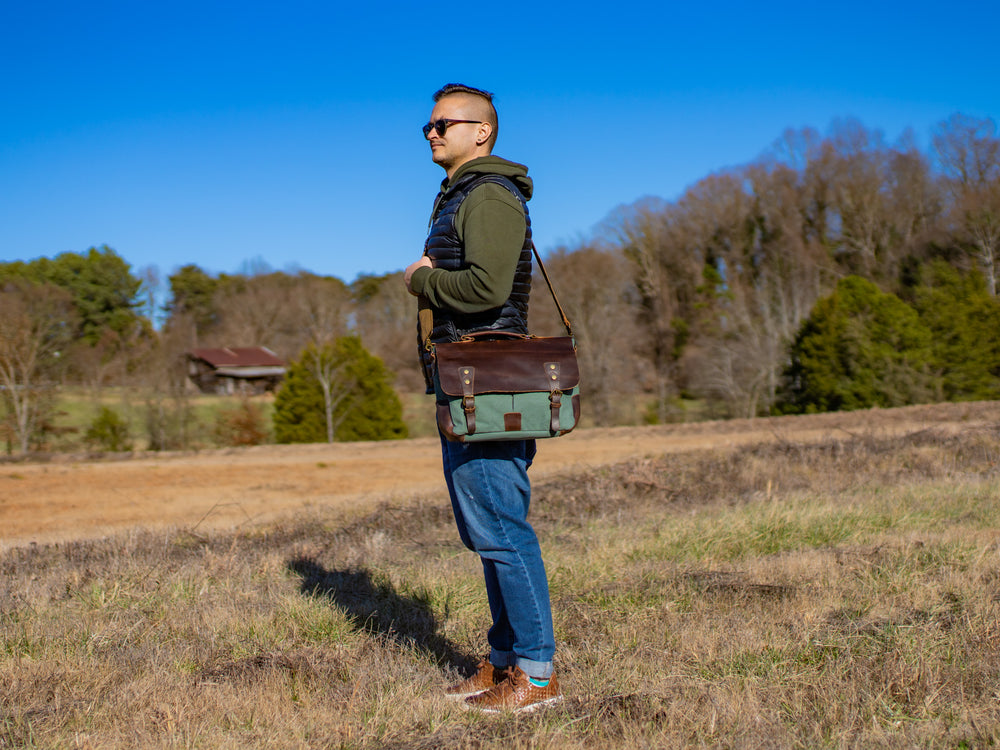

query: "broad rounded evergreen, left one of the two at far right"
xmin=778 ymin=276 xmax=936 ymax=413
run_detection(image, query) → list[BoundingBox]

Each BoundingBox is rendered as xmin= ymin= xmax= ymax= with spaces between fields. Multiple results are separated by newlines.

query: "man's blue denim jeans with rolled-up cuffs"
xmin=441 ymin=436 xmax=555 ymax=679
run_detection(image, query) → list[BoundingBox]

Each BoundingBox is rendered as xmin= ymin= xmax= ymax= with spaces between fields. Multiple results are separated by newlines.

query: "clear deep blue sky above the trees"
xmin=0 ymin=0 xmax=1000 ymax=288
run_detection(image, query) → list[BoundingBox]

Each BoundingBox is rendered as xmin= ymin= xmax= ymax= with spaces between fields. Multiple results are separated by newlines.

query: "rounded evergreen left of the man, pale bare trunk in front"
xmin=273 ymin=336 xmax=407 ymax=443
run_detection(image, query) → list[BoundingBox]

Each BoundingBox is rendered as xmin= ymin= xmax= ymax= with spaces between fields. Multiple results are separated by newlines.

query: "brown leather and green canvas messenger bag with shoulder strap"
xmin=425 ymin=245 xmax=580 ymax=442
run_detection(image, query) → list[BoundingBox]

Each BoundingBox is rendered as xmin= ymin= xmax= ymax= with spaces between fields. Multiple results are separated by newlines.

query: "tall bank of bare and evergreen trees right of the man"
xmin=536 ymin=115 xmax=1000 ymax=424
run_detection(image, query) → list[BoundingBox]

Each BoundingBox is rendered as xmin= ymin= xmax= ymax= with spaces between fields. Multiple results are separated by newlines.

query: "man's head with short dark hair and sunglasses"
xmin=424 ymin=83 xmax=499 ymax=177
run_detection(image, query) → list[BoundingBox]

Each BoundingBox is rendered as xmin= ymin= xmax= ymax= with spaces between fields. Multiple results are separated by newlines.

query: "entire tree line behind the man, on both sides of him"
xmin=0 ymin=114 xmax=1000 ymax=448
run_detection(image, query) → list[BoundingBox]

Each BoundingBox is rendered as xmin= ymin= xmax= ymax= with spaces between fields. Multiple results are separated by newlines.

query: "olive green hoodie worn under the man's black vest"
xmin=410 ymin=156 xmax=532 ymax=313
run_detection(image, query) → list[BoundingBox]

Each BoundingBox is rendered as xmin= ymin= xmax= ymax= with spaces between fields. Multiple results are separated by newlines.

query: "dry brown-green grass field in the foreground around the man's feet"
xmin=0 ymin=414 xmax=1000 ymax=748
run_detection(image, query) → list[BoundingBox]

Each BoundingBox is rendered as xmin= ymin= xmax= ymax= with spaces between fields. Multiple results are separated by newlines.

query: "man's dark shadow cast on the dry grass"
xmin=288 ymin=557 xmax=475 ymax=672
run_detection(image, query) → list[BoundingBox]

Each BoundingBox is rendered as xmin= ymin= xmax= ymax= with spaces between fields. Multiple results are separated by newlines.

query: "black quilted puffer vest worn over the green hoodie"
xmin=420 ymin=172 xmax=531 ymax=393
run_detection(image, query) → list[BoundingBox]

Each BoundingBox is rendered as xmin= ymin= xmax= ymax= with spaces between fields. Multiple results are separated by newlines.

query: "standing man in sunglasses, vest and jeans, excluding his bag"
xmin=404 ymin=84 xmax=562 ymax=712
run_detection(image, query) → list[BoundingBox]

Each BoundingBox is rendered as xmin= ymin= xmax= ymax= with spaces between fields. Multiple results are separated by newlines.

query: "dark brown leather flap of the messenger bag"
xmin=435 ymin=336 xmax=580 ymax=396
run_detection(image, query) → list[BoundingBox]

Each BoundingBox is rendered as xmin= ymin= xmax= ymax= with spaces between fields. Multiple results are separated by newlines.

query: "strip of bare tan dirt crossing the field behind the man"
xmin=0 ymin=402 xmax=1000 ymax=547
